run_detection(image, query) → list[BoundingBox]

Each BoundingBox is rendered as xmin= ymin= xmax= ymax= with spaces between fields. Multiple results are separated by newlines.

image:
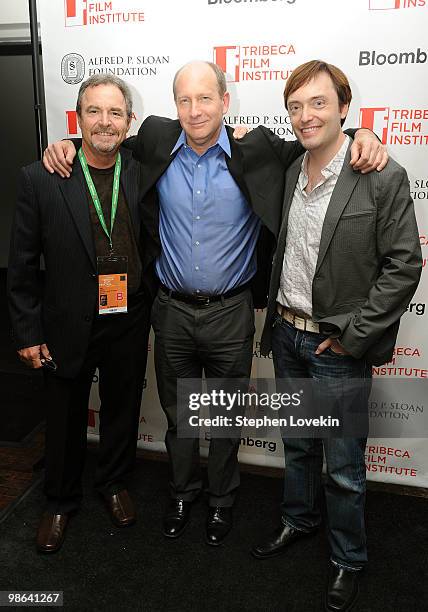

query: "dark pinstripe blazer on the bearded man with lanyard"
xmin=8 ymin=148 xmax=144 ymax=377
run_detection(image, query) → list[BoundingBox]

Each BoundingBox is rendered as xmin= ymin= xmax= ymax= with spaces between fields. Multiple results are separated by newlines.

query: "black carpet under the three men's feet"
xmin=0 ymin=450 xmax=428 ymax=612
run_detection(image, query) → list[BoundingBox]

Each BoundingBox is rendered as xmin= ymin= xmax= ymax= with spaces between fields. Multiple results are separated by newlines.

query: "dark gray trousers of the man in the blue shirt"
xmin=152 ymin=289 xmax=255 ymax=507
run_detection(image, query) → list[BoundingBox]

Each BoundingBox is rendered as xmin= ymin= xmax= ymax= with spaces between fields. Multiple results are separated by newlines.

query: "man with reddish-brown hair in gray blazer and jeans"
xmin=252 ymin=60 xmax=421 ymax=611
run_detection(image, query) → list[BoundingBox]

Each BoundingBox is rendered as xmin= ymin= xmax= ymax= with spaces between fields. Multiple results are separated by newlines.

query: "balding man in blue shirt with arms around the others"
xmin=41 ymin=62 xmax=379 ymax=545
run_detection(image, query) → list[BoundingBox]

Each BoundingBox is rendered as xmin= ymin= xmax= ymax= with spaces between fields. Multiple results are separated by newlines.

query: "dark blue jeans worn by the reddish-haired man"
xmin=272 ymin=314 xmax=371 ymax=570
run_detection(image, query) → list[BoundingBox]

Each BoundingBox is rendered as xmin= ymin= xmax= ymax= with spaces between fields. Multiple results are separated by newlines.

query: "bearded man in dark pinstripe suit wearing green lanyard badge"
xmin=8 ymin=75 xmax=151 ymax=553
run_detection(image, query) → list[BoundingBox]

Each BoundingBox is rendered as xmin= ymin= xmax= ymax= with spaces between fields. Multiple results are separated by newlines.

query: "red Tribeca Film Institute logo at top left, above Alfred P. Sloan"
xmin=64 ymin=0 xmax=144 ymax=28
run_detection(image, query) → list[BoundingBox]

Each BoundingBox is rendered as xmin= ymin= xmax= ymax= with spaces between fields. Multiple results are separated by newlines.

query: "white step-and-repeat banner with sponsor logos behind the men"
xmin=39 ymin=0 xmax=428 ymax=487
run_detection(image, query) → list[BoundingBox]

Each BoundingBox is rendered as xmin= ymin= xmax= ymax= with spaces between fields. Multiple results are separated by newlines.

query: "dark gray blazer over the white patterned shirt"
xmin=261 ymin=141 xmax=422 ymax=365
